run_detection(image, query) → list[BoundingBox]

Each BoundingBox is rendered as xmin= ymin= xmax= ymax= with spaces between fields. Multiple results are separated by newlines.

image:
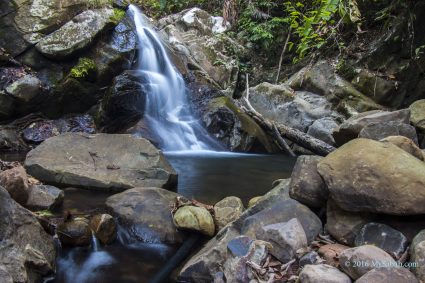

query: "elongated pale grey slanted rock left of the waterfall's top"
xmin=36 ymin=8 xmax=114 ymax=58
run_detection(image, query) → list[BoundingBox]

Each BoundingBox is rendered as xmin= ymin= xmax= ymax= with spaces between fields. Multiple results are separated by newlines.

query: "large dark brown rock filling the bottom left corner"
xmin=0 ymin=187 xmax=56 ymax=282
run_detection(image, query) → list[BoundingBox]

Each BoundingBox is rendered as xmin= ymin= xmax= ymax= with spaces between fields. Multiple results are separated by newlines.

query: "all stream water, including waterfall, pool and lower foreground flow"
xmin=37 ymin=5 xmax=294 ymax=283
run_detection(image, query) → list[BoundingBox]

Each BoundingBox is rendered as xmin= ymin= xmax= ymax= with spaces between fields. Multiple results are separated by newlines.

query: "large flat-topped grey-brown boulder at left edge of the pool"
xmin=25 ymin=133 xmax=177 ymax=191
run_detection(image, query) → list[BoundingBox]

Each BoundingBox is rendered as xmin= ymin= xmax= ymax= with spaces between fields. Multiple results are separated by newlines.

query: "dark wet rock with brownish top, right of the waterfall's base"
xmin=202 ymin=96 xmax=274 ymax=152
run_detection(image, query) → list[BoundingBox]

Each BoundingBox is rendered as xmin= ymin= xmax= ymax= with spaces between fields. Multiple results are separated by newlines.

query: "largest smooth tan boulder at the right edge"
xmin=318 ymin=139 xmax=425 ymax=215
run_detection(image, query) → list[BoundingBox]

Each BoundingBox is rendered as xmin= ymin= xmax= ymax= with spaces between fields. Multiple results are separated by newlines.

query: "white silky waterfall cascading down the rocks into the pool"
xmin=129 ymin=5 xmax=214 ymax=151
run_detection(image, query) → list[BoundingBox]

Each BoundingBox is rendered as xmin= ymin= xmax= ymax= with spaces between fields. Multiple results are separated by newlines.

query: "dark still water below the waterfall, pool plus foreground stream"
xmin=0 ymin=152 xmax=295 ymax=283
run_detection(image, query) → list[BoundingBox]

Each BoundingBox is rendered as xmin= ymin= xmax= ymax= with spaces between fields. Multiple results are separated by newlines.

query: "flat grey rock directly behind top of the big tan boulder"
xmin=359 ymin=122 xmax=418 ymax=144
